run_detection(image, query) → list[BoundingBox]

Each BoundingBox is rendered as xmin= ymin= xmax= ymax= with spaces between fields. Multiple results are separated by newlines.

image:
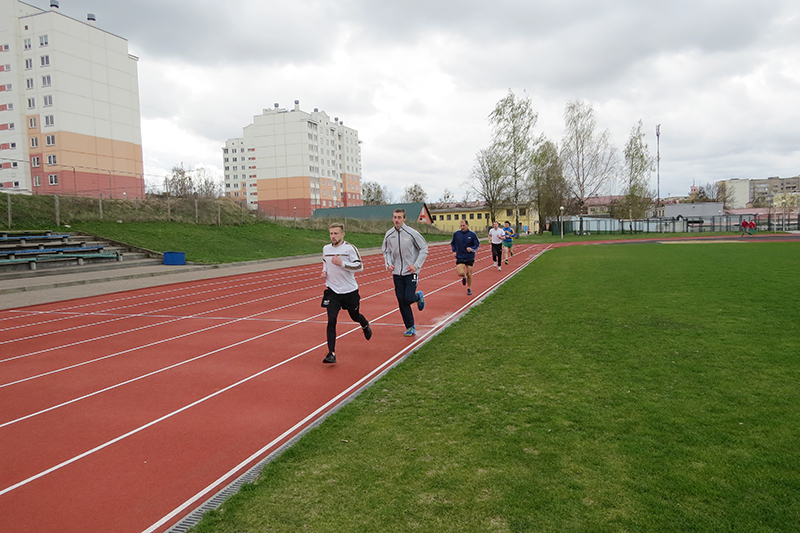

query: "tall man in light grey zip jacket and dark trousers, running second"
xmin=381 ymin=209 xmax=428 ymax=337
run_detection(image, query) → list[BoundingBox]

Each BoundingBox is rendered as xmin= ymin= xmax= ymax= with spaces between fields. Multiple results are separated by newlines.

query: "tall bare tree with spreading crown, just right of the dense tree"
xmin=561 ymin=100 xmax=617 ymax=234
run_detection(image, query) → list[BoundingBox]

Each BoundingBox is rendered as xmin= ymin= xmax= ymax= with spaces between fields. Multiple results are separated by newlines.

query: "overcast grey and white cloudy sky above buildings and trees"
xmin=42 ymin=0 xmax=800 ymax=201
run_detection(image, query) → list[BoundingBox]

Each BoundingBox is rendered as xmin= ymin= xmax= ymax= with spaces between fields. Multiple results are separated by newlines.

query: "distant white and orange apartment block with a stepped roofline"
xmin=222 ymin=100 xmax=363 ymax=218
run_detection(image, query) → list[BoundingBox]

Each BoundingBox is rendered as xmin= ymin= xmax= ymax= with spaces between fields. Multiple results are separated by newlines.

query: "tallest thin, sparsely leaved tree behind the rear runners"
xmin=489 ymin=89 xmax=539 ymax=232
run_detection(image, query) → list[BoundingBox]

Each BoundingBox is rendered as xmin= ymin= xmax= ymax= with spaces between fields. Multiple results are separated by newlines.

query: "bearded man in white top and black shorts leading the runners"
xmin=322 ymin=222 xmax=372 ymax=363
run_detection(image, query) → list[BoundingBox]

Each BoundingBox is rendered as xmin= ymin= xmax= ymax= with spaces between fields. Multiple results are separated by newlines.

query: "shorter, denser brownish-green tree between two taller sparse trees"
xmin=529 ymin=140 xmax=569 ymax=234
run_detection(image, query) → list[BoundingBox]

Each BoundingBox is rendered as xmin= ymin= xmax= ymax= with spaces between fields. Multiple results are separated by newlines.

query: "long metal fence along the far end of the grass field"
xmin=550 ymin=211 xmax=800 ymax=235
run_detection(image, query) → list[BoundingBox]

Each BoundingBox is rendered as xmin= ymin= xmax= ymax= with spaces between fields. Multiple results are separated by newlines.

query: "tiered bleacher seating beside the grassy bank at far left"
xmin=0 ymin=231 xmax=122 ymax=271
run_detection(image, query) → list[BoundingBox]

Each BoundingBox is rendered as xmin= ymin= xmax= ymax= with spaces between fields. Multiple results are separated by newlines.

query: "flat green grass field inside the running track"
xmin=196 ymin=243 xmax=800 ymax=533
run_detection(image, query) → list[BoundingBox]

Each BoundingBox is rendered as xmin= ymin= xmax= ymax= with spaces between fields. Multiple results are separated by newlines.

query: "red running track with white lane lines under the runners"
xmin=0 ymin=244 xmax=547 ymax=533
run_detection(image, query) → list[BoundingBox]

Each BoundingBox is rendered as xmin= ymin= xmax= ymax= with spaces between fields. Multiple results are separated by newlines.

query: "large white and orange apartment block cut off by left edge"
xmin=0 ymin=0 xmax=145 ymax=198
